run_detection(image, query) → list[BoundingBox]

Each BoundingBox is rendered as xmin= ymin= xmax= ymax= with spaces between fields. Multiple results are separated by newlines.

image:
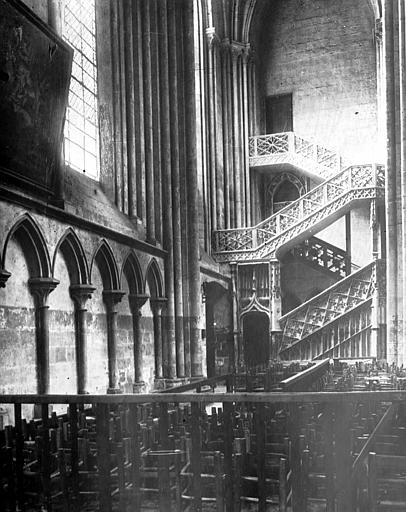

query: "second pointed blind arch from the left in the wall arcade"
xmin=52 ymin=228 xmax=89 ymax=284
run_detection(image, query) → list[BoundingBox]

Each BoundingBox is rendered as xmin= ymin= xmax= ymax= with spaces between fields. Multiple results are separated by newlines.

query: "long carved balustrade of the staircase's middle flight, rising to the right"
xmin=213 ymin=164 xmax=385 ymax=262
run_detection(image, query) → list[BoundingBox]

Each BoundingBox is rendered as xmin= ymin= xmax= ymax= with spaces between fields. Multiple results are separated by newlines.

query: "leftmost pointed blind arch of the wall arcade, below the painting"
xmin=2 ymin=213 xmax=51 ymax=277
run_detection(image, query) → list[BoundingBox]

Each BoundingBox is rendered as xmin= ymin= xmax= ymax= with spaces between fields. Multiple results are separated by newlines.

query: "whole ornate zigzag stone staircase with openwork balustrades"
xmin=213 ymin=132 xmax=385 ymax=359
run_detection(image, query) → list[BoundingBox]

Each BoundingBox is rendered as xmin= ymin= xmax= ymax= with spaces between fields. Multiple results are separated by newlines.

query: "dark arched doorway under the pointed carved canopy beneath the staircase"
xmin=242 ymin=311 xmax=269 ymax=367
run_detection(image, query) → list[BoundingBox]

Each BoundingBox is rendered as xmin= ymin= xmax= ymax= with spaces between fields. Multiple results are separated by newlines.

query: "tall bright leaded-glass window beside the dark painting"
xmin=63 ymin=0 xmax=99 ymax=178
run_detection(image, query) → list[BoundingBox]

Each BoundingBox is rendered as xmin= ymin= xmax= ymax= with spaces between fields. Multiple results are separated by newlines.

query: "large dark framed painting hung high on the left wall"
xmin=0 ymin=0 xmax=73 ymax=196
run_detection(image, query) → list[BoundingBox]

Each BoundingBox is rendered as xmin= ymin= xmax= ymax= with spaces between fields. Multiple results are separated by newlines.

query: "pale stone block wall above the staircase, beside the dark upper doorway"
xmin=258 ymin=0 xmax=378 ymax=163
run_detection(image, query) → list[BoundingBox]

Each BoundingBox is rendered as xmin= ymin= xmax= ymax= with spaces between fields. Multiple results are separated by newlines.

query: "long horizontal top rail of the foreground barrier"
xmin=0 ymin=391 xmax=406 ymax=404
